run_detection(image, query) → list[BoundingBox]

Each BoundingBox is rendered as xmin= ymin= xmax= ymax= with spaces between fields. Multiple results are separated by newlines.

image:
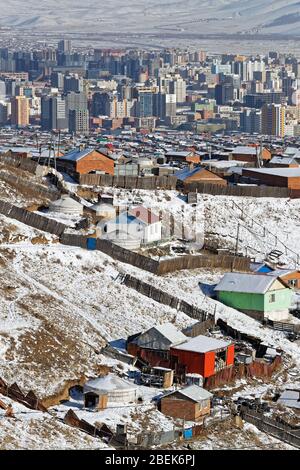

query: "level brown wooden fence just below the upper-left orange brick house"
xmin=79 ymin=174 xmax=177 ymax=190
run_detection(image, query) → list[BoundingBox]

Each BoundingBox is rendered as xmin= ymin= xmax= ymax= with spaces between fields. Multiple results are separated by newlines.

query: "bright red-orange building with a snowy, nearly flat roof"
xmin=170 ymin=335 xmax=234 ymax=378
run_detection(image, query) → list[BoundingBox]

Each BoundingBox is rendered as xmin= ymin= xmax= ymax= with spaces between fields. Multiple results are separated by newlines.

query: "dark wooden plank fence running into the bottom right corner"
xmin=241 ymin=406 xmax=300 ymax=449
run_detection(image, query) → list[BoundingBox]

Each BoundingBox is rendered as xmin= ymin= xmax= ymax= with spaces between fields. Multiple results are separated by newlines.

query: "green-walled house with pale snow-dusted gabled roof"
xmin=214 ymin=273 xmax=292 ymax=321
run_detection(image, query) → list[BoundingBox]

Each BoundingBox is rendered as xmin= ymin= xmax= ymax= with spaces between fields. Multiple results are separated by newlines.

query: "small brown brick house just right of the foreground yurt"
xmin=159 ymin=385 xmax=213 ymax=421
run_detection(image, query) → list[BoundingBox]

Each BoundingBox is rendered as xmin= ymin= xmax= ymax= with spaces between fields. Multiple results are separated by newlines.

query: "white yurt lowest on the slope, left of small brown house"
xmin=83 ymin=374 xmax=137 ymax=404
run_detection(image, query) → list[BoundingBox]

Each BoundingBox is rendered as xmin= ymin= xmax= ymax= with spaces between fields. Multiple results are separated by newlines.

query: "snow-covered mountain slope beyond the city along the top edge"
xmin=0 ymin=0 xmax=300 ymax=36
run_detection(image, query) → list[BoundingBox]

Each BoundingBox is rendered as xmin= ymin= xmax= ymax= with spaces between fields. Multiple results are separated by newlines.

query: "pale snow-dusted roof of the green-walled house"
xmin=214 ymin=273 xmax=276 ymax=294
